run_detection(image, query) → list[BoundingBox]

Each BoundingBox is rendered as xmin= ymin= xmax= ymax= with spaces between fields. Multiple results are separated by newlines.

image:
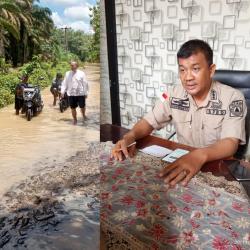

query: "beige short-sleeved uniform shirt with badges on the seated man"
xmin=144 ymin=81 xmax=247 ymax=147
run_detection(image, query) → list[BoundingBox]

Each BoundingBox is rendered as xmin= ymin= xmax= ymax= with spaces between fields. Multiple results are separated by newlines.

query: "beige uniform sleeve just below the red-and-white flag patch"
xmin=144 ymin=100 xmax=171 ymax=130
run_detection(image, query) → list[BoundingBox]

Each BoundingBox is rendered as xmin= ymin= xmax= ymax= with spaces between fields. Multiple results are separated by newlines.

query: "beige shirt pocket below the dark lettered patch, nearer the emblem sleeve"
xmin=202 ymin=115 xmax=224 ymax=146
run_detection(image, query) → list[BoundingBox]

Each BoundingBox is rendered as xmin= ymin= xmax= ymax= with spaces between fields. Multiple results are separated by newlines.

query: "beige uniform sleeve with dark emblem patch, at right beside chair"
xmin=221 ymin=91 xmax=247 ymax=145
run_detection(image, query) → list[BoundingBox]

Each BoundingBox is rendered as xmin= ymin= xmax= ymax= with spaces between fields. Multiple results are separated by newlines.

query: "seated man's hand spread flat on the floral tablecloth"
xmin=160 ymin=149 xmax=206 ymax=187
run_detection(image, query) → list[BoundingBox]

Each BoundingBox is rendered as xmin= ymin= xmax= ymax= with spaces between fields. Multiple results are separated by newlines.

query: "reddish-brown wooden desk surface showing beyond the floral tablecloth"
xmin=100 ymin=124 xmax=235 ymax=181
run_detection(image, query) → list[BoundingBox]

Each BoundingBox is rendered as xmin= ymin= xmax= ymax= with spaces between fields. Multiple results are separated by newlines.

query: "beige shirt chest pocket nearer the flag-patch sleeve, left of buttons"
xmin=172 ymin=111 xmax=192 ymax=145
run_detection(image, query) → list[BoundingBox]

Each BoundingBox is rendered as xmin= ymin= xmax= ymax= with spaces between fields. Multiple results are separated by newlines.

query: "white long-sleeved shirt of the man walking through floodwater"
xmin=61 ymin=70 xmax=89 ymax=96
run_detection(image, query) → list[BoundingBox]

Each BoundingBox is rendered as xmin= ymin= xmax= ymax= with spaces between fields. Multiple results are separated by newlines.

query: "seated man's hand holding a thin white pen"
xmin=111 ymin=138 xmax=136 ymax=161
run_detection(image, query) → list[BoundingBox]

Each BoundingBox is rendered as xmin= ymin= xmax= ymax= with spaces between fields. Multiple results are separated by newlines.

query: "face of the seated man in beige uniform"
xmin=178 ymin=52 xmax=215 ymax=98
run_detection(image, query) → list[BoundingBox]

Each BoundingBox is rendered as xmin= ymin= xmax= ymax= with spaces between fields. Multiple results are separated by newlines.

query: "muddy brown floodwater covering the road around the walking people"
xmin=0 ymin=65 xmax=100 ymax=196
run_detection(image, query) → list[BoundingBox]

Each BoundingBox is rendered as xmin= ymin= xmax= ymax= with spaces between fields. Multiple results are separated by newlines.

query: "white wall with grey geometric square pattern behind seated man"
xmin=116 ymin=0 xmax=250 ymax=136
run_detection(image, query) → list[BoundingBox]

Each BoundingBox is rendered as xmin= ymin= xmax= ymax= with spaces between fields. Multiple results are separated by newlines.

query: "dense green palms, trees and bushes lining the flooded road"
xmin=0 ymin=0 xmax=100 ymax=107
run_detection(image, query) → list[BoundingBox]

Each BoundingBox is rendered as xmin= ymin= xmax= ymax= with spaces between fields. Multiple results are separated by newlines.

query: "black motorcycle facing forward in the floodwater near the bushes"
xmin=23 ymin=77 xmax=44 ymax=121
